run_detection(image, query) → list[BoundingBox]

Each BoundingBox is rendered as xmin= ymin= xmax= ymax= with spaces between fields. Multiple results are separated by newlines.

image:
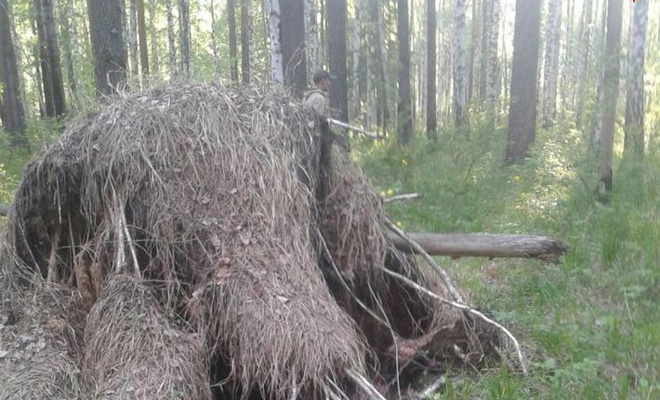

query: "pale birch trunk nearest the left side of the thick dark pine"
xmin=485 ymin=0 xmax=500 ymax=114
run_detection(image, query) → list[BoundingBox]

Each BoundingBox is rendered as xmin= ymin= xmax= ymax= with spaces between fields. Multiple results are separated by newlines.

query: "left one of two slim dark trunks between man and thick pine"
xmin=397 ymin=0 xmax=413 ymax=146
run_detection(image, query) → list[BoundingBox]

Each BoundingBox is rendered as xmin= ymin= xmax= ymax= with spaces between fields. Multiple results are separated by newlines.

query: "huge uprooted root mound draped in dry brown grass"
xmin=0 ymin=84 xmax=510 ymax=399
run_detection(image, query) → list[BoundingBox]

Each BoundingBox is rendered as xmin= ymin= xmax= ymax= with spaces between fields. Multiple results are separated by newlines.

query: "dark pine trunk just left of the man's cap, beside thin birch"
xmin=280 ymin=0 xmax=306 ymax=97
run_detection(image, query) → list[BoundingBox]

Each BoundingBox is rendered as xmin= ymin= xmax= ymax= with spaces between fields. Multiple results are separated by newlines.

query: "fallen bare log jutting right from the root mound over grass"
xmin=389 ymin=233 xmax=568 ymax=264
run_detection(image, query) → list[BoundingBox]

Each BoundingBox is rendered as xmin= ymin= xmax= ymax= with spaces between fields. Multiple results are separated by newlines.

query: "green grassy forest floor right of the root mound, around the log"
xmin=355 ymin=122 xmax=660 ymax=399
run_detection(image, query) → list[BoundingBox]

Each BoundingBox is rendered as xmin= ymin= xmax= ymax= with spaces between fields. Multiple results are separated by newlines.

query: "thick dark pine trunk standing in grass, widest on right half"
xmin=504 ymin=0 xmax=541 ymax=164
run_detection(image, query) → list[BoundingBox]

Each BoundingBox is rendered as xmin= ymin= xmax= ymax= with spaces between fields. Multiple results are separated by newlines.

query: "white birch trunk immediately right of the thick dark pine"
xmin=541 ymin=0 xmax=561 ymax=129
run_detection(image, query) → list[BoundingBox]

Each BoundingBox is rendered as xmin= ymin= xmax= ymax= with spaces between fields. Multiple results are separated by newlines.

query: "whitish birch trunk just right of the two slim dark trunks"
xmin=452 ymin=0 xmax=468 ymax=127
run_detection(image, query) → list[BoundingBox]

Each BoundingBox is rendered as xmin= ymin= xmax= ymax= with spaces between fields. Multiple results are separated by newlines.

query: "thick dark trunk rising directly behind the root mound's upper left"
xmin=87 ymin=0 xmax=126 ymax=95
